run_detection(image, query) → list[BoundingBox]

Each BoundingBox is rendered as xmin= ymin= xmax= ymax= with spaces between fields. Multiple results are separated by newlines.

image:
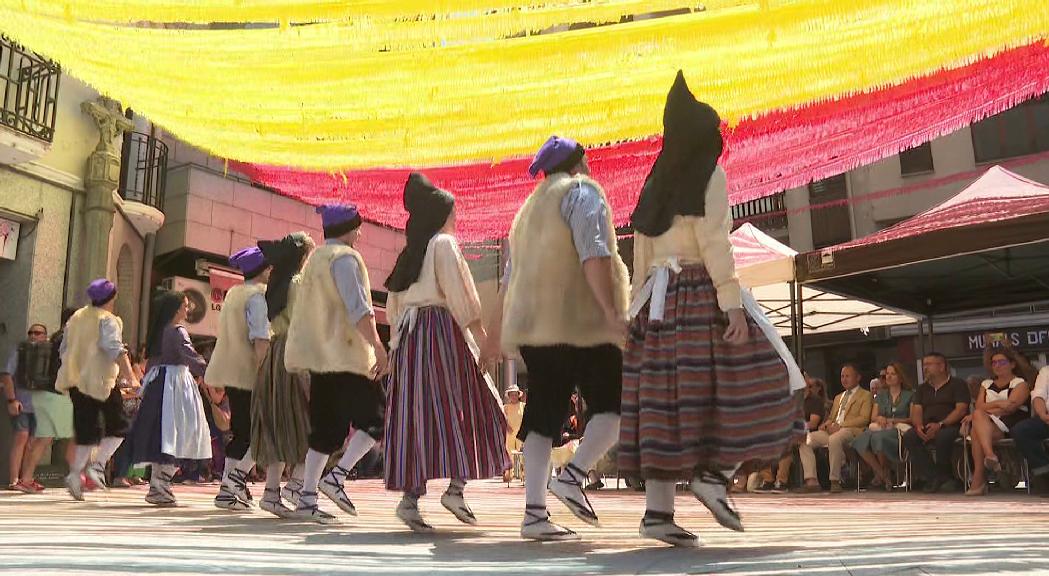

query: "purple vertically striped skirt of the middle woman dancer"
xmin=385 ymin=306 xmax=510 ymax=494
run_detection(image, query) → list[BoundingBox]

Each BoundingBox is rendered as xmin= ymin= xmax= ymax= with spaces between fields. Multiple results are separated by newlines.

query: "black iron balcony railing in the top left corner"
xmin=0 ymin=36 xmax=62 ymax=143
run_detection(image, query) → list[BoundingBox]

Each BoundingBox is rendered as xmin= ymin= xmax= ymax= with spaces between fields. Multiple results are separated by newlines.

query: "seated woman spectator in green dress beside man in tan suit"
xmin=853 ymin=362 xmax=914 ymax=490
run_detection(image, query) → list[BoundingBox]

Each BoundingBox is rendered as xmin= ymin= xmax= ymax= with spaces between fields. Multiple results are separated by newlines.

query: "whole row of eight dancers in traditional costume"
xmin=51 ymin=72 xmax=805 ymax=547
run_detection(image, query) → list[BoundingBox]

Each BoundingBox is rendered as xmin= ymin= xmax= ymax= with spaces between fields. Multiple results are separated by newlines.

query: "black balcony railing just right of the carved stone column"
xmin=120 ymin=132 xmax=168 ymax=212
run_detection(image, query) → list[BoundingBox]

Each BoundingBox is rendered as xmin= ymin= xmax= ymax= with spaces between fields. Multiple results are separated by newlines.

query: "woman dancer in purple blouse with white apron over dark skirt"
xmin=129 ymin=291 xmax=211 ymax=507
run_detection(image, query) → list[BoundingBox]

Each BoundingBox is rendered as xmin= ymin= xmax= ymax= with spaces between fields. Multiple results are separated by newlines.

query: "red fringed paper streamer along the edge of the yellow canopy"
xmin=233 ymin=41 xmax=1049 ymax=241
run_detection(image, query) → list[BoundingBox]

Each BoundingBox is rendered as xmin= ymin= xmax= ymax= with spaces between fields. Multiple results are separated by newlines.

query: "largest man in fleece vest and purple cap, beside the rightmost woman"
xmin=483 ymin=136 xmax=629 ymax=540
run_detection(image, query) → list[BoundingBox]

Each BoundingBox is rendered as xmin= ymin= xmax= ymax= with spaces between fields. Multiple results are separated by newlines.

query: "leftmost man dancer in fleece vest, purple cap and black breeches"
xmin=55 ymin=278 xmax=138 ymax=500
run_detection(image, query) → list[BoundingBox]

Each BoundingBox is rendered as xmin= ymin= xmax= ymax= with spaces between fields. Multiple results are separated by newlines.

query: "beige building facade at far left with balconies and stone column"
xmin=0 ymin=36 xmax=163 ymax=477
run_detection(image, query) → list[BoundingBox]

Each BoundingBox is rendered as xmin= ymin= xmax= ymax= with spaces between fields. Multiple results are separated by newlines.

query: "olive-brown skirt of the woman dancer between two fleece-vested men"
xmin=251 ymin=335 xmax=309 ymax=467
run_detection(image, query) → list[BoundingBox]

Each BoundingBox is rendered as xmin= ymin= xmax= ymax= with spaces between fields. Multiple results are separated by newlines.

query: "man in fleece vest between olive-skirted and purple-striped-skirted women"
xmin=284 ymin=205 xmax=386 ymax=524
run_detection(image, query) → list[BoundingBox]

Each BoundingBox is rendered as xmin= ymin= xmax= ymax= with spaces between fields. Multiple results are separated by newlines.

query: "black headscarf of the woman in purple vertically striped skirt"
xmin=386 ymin=172 xmax=455 ymax=292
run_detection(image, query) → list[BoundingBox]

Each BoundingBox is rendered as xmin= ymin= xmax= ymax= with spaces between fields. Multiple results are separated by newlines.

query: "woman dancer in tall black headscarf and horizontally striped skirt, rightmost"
xmin=619 ymin=72 xmax=805 ymax=546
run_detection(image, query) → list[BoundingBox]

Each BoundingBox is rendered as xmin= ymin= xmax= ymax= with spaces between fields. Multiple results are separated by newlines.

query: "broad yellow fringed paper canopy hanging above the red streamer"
xmin=0 ymin=0 xmax=1049 ymax=171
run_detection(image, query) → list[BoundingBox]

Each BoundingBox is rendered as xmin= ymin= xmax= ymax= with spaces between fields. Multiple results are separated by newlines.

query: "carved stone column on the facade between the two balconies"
xmin=81 ymin=97 xmax=132 ymax=285
